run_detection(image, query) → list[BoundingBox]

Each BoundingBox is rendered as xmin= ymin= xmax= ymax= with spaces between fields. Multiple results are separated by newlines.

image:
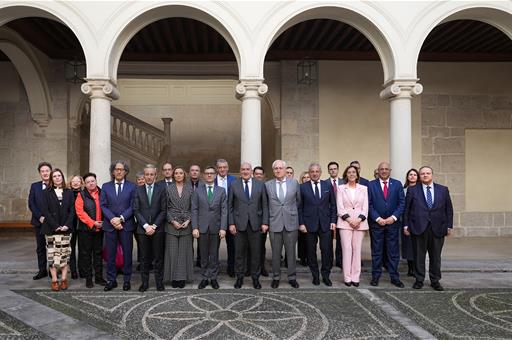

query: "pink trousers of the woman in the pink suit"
xmin=339 ymin=229 xmax=366 ymax=282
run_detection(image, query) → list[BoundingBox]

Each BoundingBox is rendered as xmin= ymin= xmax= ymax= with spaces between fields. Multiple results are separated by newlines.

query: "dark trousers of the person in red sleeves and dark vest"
xmin=75 ymin=231 xmax=103 ymax=279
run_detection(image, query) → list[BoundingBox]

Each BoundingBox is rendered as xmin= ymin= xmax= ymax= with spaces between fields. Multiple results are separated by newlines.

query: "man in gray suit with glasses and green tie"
xmin=192 ymin=166 xmax=228 ymax=289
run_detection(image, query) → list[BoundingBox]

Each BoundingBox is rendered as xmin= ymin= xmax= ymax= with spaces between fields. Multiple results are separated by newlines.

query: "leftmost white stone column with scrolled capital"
xmin=82 ymin=79 xmax=119 ymax=185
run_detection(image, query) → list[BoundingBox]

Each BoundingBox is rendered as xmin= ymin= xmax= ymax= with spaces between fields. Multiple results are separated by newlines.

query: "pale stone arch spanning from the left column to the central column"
xmin=107 ymin=2 xmax=241 ymax=82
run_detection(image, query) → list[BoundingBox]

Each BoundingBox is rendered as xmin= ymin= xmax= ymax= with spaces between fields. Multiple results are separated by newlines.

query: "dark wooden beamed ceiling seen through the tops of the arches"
xmin=0 ymin=18 xmax=512 ymax=61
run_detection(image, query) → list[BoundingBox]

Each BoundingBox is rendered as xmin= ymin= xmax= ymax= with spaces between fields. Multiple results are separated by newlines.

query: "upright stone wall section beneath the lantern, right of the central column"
xmin=281 ymin=61 xmax=319 ymax=178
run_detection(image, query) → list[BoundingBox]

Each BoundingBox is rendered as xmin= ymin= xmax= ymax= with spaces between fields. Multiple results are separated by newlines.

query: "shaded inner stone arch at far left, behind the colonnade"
xmin=0 ymin=27 xmax=52 ymax=127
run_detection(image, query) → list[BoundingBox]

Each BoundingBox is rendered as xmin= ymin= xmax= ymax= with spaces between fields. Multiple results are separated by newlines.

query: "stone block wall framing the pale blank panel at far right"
xmin=421 ymin=93 xmax=512 ymax=236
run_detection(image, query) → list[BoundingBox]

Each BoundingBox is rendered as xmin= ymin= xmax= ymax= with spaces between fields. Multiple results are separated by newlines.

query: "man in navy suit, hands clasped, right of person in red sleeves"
xmin=100 ymin=161 xmax=136 ymax=291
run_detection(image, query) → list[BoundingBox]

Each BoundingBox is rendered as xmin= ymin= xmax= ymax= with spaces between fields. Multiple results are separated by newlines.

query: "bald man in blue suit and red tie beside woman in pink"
xmin=368 ymin=162 xmax=405 ymax=288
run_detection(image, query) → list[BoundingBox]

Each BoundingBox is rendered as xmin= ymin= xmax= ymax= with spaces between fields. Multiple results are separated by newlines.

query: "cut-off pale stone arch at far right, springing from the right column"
xmin=409 ymin=1 xmax=512 ymax=74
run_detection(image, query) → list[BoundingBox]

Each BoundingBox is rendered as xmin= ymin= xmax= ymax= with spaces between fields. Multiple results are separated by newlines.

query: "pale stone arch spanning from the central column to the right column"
xmin=258 ymin=2 xmax=397 ymax=83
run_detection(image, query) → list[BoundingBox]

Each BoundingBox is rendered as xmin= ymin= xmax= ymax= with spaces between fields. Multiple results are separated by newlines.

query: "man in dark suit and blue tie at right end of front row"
xmin=404 ymin=166 xmax=453 ymax=291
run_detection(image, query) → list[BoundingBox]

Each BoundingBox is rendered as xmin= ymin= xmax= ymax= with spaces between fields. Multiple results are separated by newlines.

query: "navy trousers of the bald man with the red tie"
xmin=370 ymin=223 xmax=401 ymax=281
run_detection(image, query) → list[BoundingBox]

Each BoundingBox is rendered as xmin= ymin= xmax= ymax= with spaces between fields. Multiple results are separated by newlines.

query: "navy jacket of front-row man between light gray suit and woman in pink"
xmin=299 ymin=181 xmax=336 ymax=233
